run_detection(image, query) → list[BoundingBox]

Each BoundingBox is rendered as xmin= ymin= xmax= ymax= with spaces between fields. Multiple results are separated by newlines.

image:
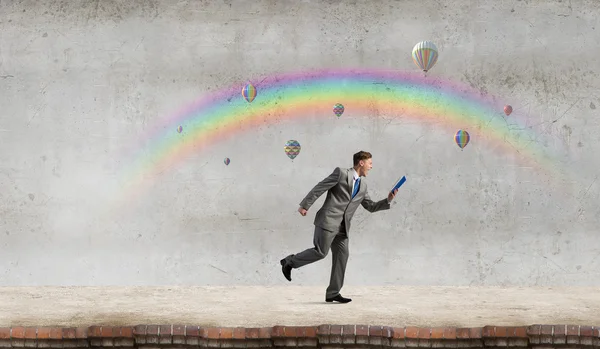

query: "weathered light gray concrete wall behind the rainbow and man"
xmin=0 ymin=0 xmax=600 ymax=286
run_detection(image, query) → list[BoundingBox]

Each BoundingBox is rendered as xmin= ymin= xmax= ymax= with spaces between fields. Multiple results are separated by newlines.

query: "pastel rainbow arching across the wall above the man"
xmin=122 ymin=69 xmax=568 ymax=201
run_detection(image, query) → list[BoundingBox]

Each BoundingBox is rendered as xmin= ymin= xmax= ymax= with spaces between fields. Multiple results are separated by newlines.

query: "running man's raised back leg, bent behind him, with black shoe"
xmin=281 ymin=226 xmax=336 ymax=281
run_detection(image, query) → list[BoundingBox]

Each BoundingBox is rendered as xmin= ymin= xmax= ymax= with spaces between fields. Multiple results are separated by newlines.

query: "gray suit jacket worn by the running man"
xmin=300 ymin=167 xmax=390 ymax=232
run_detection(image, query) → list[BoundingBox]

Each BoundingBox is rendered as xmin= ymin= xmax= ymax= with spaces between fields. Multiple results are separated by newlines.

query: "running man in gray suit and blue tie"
xmin=280 ymin=151 xmax=398 ymax=303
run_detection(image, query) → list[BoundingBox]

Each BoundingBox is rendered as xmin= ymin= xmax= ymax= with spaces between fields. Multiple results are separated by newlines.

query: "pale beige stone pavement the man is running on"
xmin=0 ymin=285 xmax=600 ymax=328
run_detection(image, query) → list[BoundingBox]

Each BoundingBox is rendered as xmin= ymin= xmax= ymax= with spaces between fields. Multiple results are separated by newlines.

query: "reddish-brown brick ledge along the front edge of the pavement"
xmin=0 ymin=325 xmax=600 ymax=349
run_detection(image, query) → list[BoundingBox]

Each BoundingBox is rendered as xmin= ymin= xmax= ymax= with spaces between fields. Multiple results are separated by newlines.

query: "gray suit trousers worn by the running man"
xmin=285 ymin=223 xmax=350 ymax=298
